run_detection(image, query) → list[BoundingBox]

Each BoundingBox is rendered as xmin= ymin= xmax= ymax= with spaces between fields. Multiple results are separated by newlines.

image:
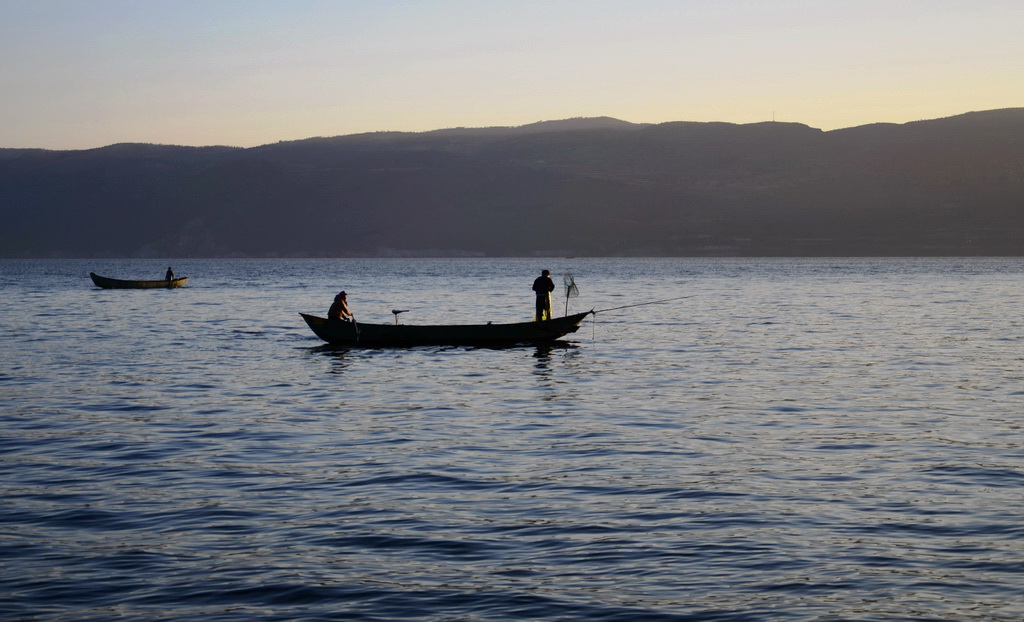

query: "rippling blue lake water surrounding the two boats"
xmin=0 ymin=258 xmax=1024 ymax=622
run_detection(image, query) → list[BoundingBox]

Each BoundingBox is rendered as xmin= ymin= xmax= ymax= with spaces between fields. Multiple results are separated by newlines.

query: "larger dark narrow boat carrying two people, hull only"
xmin=299 ymin=310 xmax=594 ymax=347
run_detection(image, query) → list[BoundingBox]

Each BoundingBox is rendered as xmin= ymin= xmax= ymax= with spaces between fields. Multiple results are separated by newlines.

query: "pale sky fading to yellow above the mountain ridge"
xmin=0 ymin=0 xmax=1024 ymax=150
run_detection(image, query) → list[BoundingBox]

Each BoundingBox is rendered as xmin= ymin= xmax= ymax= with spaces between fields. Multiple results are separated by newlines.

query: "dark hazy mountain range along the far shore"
xmin=0 ymin=109 xmax=1024 ymax=257
